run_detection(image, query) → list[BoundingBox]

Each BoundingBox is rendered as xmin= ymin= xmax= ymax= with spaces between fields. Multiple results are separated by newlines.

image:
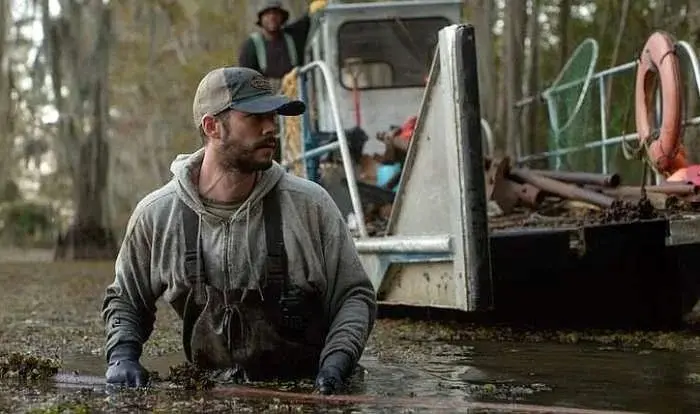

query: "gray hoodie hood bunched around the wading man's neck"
xmin=170 ymin=148 xmax=284 ymax=222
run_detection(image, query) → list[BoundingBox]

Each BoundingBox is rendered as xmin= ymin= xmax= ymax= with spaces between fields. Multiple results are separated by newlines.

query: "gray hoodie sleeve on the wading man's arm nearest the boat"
xmin=320 ymin=196 xmax=377 ymax=366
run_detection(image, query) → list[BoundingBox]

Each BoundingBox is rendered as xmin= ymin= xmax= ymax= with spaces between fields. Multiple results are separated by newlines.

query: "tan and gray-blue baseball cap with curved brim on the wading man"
xmin=192 ymin=67 xmax=306 ymax=127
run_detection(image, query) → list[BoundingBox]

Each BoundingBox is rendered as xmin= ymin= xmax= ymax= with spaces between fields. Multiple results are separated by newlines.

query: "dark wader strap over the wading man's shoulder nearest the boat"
xmin=263 ymin=186 xmax=287 ymax=301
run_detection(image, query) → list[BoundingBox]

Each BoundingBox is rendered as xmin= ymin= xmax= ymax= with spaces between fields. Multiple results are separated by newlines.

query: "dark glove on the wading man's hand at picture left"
xmin=105 ymin=342 xmax=148 ymax=387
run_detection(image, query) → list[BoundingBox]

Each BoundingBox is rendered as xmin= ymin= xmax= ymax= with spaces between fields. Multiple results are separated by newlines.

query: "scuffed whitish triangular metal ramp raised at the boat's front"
xmin=356 ymin=25 xmax=493 ymax=311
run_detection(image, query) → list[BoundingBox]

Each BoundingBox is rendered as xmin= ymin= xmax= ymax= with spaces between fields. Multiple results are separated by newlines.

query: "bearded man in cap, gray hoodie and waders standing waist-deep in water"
xmin=102 ymin=67 xmax=377 ymax=394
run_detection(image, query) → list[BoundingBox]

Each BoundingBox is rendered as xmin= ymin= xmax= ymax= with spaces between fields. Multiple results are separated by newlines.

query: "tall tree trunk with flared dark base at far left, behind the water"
xmin=44 ymin=0 xmax=117 ymax=260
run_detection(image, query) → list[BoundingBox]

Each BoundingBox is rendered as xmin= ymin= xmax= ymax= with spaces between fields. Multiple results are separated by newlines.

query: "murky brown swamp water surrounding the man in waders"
xmin=0 ymin=255 xmax=700 ymax=414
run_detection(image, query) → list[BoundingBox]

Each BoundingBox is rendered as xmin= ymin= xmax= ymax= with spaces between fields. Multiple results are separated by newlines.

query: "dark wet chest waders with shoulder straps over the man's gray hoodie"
xmin=181 ymin=187 xmax=327 ymax=381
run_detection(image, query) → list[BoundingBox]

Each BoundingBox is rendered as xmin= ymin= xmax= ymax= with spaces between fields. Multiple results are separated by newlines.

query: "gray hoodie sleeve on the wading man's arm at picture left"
xmin=102 ymin=208 xmax=163 ymax=357
